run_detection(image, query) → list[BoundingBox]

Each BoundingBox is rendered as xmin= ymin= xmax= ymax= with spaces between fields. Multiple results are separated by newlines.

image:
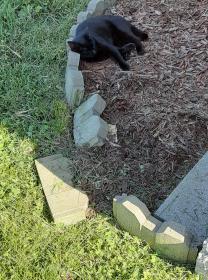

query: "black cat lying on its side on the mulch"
xmin=68 ymin=16 xmax=148 ymax=70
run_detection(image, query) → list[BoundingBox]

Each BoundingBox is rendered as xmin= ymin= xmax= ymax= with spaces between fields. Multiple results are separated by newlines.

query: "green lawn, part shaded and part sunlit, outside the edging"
xmin=0 ymin=0 xmax=197 ymax=280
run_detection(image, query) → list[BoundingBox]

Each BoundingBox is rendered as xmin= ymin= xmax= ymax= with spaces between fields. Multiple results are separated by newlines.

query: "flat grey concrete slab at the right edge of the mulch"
xmin=155 ymin=152 xmax=208 ymax=245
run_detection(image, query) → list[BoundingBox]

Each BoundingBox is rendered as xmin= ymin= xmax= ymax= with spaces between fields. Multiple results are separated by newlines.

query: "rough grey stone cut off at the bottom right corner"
xmin=195 ymin=239 xmax=208 ymax=280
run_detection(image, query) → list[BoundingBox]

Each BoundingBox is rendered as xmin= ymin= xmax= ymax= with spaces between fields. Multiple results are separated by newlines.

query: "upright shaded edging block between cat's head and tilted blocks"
xmin=65 ymin=67 xmax=84 ymax=109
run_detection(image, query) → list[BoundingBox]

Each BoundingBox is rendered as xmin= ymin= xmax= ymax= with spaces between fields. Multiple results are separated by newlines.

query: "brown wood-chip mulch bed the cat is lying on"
xmin=72 ymin=0 xmax=208 ymax=211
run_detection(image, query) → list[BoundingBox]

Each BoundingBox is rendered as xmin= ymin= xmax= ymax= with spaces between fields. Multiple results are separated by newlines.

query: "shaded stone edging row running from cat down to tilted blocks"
xmin=65 ymin=0 xmax=116 ymax=147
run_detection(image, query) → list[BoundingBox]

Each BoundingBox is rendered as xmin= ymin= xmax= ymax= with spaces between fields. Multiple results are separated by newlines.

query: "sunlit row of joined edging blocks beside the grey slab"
xmin=113 ymin=195 xmax=198 ymax=264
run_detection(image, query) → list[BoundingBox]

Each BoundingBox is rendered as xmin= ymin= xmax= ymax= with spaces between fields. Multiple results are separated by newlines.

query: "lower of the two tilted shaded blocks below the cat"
xmin=74 ymin=116 xmax=108 ymax=147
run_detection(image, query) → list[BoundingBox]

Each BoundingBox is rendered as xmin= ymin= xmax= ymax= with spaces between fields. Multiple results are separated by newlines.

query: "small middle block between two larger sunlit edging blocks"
xmin=140 ymin=216 xmax=162 ymax=248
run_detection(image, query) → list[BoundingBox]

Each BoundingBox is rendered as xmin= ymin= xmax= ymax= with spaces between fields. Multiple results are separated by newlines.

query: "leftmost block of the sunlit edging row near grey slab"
xmin=113 ymin=195 xmax=150 ymax=237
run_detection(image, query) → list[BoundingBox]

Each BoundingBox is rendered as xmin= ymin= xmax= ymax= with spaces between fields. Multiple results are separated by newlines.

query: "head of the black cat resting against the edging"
xmin=67 ymin=36 xmax=96 ymax=59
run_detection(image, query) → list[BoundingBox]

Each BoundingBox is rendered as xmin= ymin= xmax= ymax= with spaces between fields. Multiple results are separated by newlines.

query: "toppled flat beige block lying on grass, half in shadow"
xmin=35 ymin=154 xmax=88 ymax=224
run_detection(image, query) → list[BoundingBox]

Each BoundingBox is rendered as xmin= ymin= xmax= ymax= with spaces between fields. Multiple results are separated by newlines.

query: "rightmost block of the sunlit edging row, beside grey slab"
xmin=155 ymin=222 xmax=191 ymax=263
